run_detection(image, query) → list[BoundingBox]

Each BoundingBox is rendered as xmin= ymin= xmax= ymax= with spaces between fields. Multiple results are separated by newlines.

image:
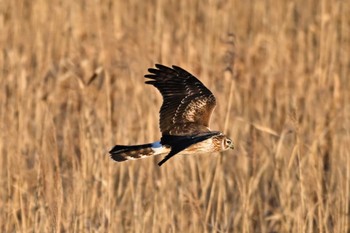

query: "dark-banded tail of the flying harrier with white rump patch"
xmin=109 ymin=141 xmax=170 ymax=162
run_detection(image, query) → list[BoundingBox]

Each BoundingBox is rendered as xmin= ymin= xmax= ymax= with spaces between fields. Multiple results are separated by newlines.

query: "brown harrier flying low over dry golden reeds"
xmin=109 ymin=64 xmax=233 ymax=166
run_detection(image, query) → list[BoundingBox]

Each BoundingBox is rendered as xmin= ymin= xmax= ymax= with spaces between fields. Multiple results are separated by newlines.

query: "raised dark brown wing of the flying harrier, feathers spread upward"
xmin=145 ymin=64 xmax=216 ymax=135
